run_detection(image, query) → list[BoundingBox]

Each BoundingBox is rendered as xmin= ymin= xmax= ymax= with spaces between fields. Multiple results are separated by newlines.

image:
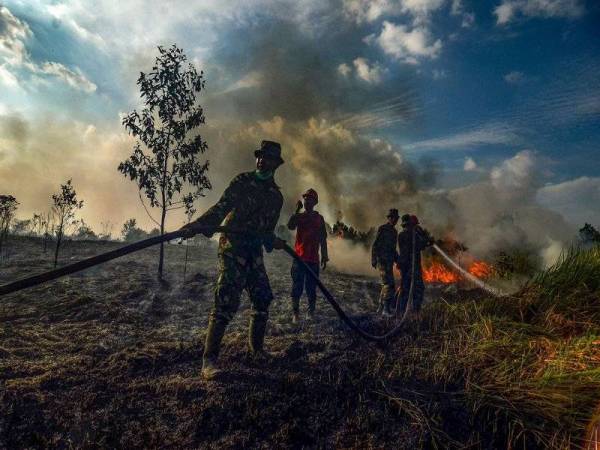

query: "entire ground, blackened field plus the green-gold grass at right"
xmin=0 ymin=238 xmax=600 ymax=448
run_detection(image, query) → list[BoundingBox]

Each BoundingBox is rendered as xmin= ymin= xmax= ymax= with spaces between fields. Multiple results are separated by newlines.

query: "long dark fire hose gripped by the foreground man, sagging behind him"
xmin=0 ymin=227 xmax=504 ymax=343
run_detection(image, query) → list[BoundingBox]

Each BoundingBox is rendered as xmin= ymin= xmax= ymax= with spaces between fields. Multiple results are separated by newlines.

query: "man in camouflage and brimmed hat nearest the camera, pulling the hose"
xmin=183 ymin=141 xmax=284 ymax=379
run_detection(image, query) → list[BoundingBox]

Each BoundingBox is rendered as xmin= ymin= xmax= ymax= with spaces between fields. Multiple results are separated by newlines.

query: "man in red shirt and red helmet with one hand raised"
xmin=288 ymin=189 xmax=329 ymax=323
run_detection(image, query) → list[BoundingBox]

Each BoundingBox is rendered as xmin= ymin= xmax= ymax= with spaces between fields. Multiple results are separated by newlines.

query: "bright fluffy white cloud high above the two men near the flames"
xmin=377 ymin=21 xmax=442 ymax=64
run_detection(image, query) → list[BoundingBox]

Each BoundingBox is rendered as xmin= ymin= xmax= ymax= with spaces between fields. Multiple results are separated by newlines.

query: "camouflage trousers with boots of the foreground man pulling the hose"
xmin=204 ymin=253 xmax=273 ymax=360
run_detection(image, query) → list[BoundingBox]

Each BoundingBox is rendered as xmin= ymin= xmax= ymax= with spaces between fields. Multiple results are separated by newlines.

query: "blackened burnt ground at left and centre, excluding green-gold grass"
xmin=0 ymin=239 xmax=460 ymax=448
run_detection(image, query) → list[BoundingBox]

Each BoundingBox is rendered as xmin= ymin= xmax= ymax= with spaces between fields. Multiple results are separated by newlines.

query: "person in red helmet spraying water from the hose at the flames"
xmin=398 ymin=214 xmax=434 ymax=315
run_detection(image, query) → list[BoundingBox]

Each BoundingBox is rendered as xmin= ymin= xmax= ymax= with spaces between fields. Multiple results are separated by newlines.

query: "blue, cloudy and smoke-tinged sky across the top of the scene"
xmin=0 ymin=0 xmax=600 ymax=246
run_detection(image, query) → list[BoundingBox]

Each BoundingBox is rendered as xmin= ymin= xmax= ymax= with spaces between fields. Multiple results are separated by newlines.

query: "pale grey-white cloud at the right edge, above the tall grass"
xmin=537 ymin=177 xmax=600 ymax=227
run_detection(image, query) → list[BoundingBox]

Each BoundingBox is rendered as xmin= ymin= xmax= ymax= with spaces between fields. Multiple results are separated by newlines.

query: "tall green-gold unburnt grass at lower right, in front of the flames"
xmin=380 ymin=247 xmax=600 ymax=448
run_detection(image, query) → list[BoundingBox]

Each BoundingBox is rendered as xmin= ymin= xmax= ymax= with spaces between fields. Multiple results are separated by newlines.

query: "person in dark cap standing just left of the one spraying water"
xmin=371 ymin=209 xmax=399 ymax=315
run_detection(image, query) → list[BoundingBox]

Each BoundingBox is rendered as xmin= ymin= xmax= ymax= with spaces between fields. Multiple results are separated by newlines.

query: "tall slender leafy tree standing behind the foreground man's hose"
xmin=118 ymin=45 xmax=211 ymax=278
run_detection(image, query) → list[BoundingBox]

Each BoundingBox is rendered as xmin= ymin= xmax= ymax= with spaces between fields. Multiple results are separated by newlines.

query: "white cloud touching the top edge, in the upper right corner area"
xmin=494 ymin=0 xmax=584 ymax=25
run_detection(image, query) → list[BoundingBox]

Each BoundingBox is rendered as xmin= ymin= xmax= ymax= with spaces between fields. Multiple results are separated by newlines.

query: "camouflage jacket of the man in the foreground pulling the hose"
xmin=196 ymin=172 xmax=283 ymax=255
